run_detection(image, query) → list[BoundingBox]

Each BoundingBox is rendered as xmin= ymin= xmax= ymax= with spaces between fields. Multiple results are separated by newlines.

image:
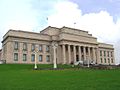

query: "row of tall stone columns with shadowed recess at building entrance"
xmin=55 ymin=44 xmax=98 ymax=64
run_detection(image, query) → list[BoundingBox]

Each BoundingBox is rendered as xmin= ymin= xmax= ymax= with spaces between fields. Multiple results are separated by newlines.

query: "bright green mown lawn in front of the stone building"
xmin=0 ymin=64 xmax=120 ymax=90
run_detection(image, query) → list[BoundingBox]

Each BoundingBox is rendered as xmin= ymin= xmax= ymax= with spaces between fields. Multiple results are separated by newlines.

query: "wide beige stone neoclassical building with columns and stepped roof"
xmin=2 ymin=26 xmax=115 ymax=65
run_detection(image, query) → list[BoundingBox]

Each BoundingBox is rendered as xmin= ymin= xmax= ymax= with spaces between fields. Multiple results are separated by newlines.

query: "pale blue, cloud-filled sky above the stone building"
xmin=0 ymin=0 xmax=120 ymax=64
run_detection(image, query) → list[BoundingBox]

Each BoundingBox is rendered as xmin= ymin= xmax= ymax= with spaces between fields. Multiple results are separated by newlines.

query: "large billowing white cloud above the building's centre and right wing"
xmin=48 ymin=1 xmax=120 ymax=62
